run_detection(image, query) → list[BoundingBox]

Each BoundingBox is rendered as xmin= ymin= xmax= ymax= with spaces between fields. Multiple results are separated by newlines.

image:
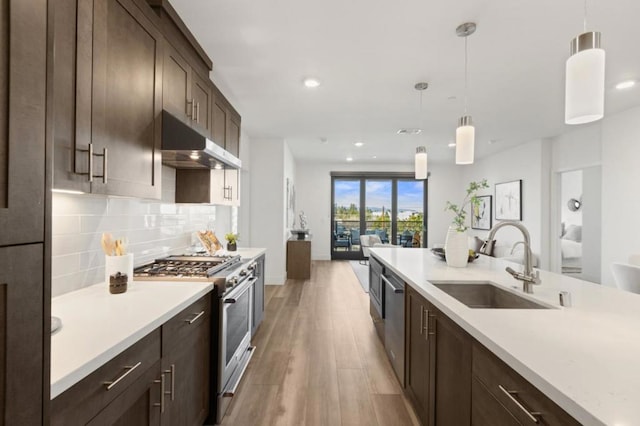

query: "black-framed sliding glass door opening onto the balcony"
xmin=331 ymin=173 xmax=427 ymax=259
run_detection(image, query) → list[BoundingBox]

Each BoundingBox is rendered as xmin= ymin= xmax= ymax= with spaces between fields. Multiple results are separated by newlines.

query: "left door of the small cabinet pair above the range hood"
xmin=162 ymin=43 xmax=194 ymax=124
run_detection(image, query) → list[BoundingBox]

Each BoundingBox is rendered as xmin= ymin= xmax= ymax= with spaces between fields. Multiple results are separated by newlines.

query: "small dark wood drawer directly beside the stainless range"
xmin=162 ymin=294 xmax=211 ymax=356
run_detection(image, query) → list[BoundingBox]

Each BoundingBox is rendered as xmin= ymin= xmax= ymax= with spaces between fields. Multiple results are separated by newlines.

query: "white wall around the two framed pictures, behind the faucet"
xmin=460 ymin=140 xmax=548 ymax=268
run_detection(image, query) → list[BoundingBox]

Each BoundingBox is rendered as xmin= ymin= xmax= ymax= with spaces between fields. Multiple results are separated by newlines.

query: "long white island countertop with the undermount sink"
xmin=372 ymin=247 xmax=640 ymax=426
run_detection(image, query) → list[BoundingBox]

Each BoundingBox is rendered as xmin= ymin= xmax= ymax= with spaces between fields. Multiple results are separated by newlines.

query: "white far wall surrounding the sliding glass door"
xmin=296 ymin=162 xmax=459 ymax=260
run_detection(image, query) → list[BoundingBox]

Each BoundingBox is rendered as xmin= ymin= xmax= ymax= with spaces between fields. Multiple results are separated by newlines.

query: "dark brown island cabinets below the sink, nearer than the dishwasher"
xmin=405 ymin=285 xmax=580 ymax=426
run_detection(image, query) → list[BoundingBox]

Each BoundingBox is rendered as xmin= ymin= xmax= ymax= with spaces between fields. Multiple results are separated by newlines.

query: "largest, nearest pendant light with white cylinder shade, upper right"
xmin=564 ymin=0 xmax=605 ymax=124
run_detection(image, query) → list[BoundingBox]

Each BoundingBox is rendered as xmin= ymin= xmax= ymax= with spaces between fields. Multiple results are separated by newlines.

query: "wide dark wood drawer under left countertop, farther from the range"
xmin=51 ymin=329 xmax=160 ymax=426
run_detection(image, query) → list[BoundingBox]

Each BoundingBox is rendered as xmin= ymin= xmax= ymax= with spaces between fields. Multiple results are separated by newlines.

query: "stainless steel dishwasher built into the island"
xmin=381 ymin=270 xmax=404 ymax=387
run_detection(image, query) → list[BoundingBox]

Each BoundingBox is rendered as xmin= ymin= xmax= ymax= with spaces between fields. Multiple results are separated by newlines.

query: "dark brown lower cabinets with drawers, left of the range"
xmin=52 ymin=295 xmax=211 ymax=426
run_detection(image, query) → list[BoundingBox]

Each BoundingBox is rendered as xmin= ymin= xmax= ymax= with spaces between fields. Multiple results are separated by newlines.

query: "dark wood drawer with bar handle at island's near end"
xmin=473 ymin=343 xmax=580 ymax=425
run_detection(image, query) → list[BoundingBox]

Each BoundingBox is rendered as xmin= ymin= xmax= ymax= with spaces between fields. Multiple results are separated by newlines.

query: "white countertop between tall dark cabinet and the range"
xmin=51 ymin=281 xmax=213 ymax=399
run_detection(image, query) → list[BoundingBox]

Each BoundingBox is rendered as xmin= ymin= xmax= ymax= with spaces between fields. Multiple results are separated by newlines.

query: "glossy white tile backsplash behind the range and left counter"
xmin=52 ymin=167 xmax=237 ymax=296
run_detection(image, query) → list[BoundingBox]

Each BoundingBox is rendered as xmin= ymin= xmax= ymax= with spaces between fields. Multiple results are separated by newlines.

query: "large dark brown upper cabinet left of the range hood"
xmin=53 ymin=0 xmax=164 ymax=199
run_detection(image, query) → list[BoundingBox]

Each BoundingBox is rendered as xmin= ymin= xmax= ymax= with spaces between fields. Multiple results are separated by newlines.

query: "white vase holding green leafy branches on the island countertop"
xmin=444 ymin=179 xmax=489 ymax=268
